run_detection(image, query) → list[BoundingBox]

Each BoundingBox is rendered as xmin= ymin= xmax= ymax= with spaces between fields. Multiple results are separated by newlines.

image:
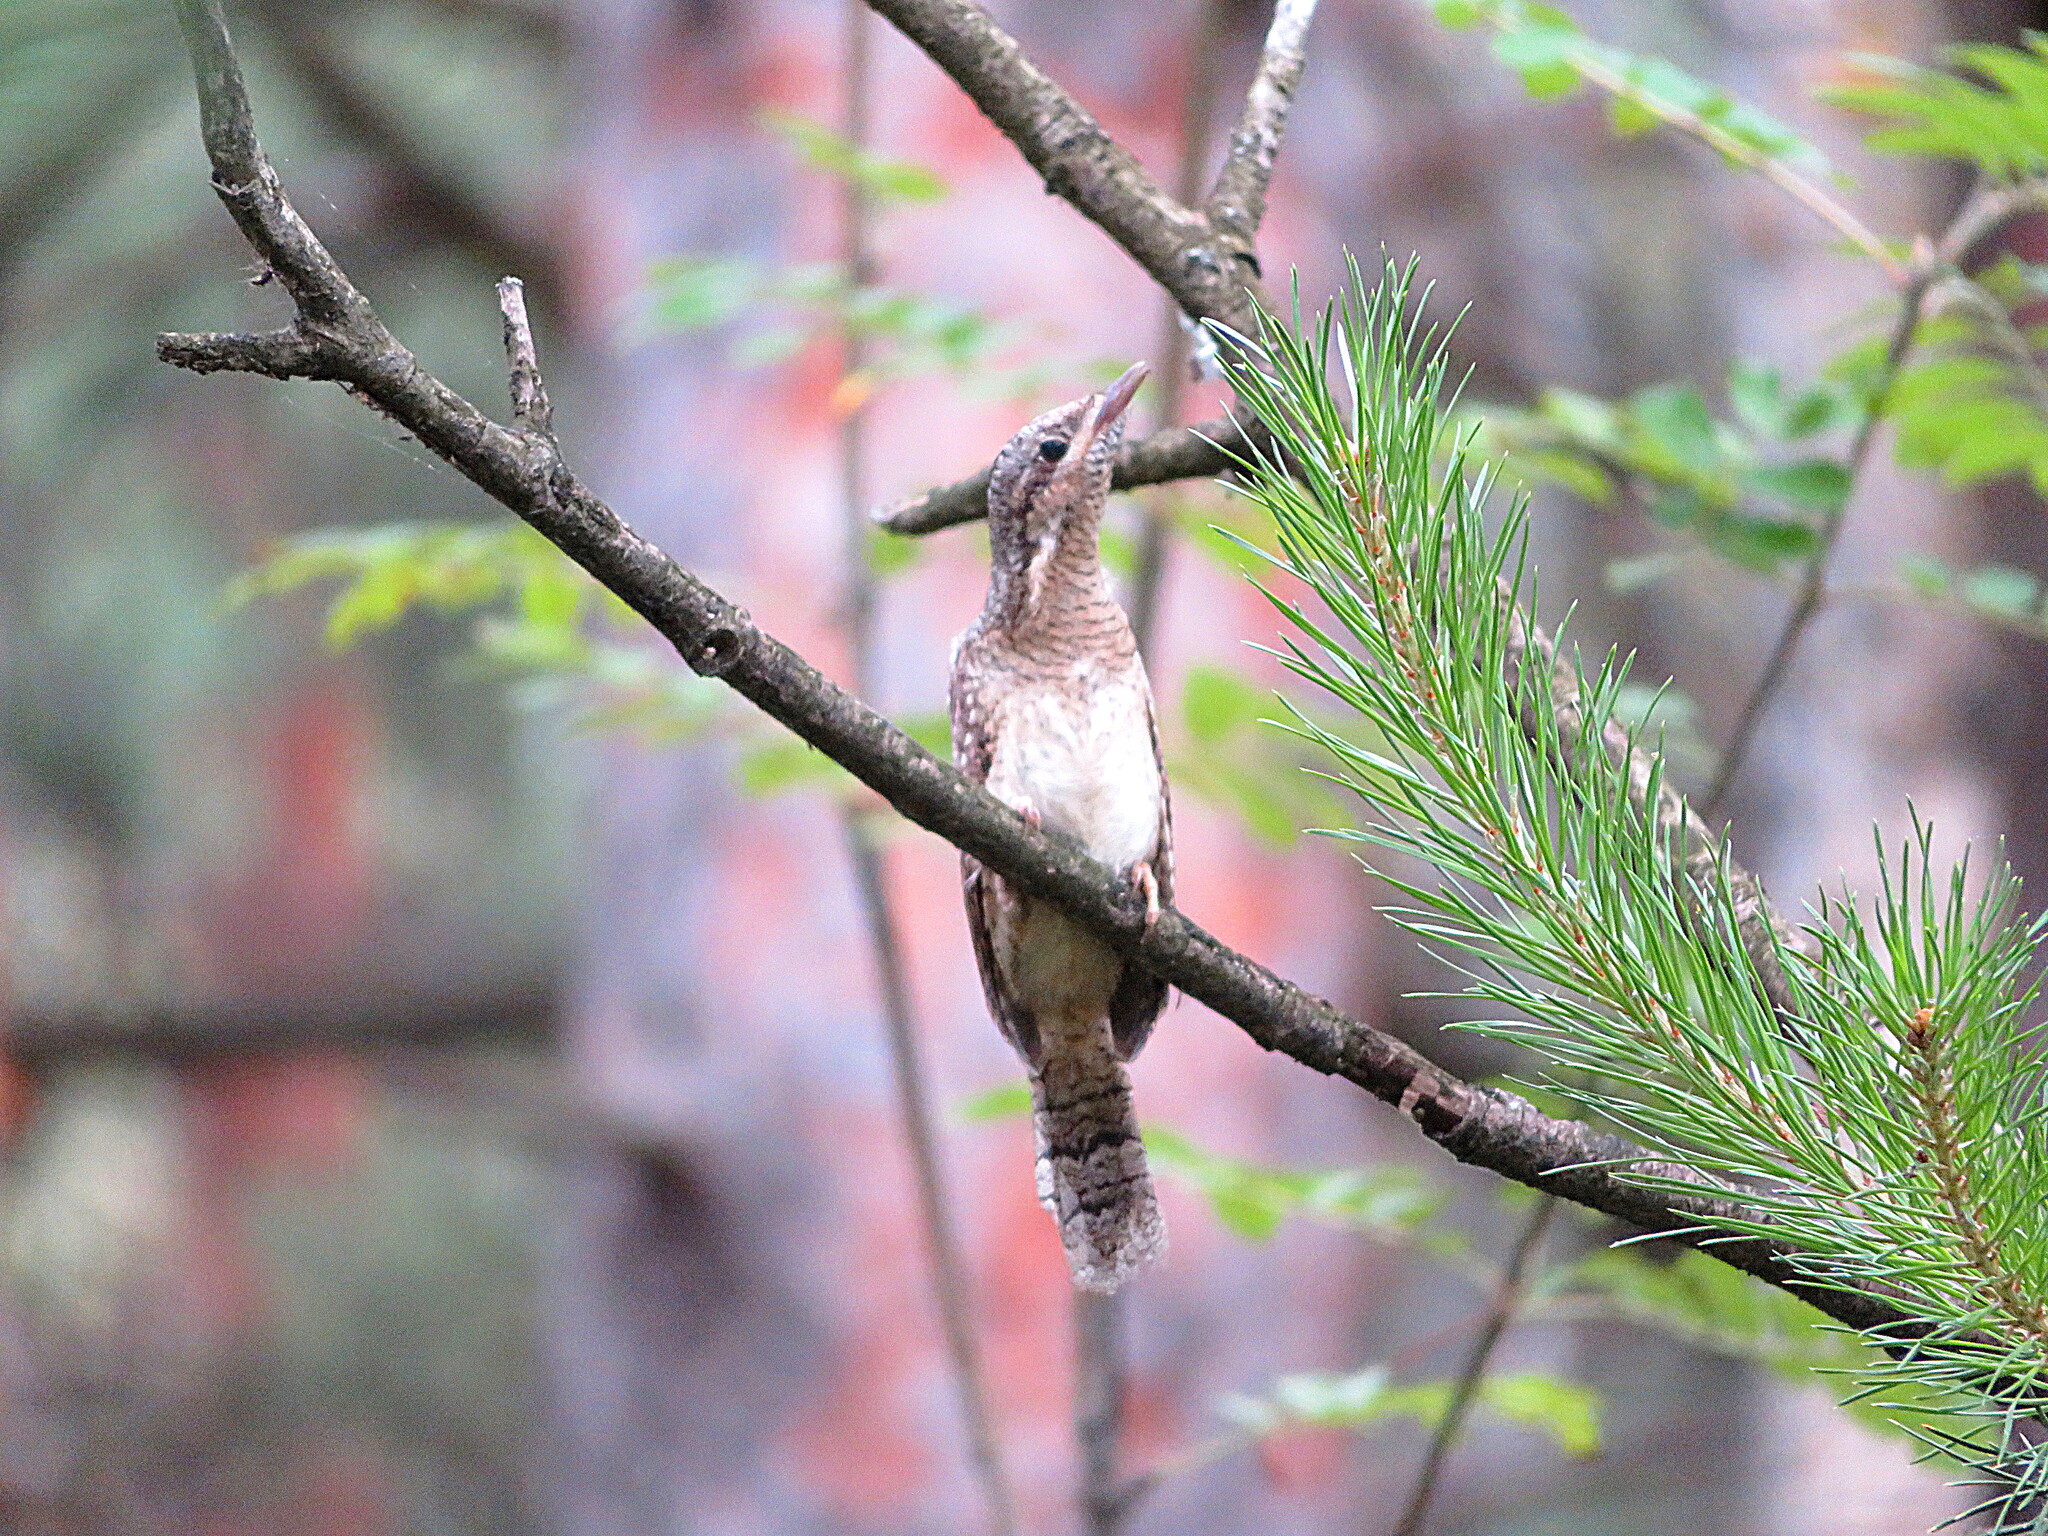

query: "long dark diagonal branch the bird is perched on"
xmin=158 ymin=0 xmax=1921 ymax=1339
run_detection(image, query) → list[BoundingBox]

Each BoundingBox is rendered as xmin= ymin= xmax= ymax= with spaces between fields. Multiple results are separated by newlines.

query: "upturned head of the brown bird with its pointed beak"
xmin=989 ymin=362 xmax=1147 ymax=592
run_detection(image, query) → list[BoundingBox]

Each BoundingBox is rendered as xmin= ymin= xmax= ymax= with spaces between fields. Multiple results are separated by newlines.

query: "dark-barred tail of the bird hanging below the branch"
xmin=1032 ymin=1036 xmax=1165 ymax=1292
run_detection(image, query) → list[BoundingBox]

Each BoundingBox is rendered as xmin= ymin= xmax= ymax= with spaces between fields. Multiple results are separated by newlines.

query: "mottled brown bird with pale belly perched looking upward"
xmin=948 ymin=362 xmax=1174 ymax=1292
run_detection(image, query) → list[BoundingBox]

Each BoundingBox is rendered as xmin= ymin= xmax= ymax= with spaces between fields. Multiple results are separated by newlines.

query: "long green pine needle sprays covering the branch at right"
xmin=1225 ymin=262 xmax=2048 ymax=1530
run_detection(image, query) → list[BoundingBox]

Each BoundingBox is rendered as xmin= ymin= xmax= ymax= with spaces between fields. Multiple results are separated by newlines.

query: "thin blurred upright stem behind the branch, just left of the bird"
xmin=840 ymin=0 xmax=1018 ymax=1536
